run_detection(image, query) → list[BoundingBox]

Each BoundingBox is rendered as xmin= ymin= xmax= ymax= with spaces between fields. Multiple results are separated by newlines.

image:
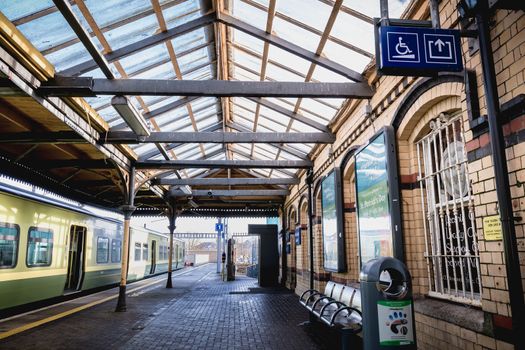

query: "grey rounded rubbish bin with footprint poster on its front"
xmin=359 ymin=257 xmax=417 ymax=350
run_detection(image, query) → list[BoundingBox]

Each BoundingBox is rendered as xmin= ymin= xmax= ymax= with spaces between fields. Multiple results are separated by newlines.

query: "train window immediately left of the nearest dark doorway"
xmin=26 ymin=227 xmax=53 ymax=267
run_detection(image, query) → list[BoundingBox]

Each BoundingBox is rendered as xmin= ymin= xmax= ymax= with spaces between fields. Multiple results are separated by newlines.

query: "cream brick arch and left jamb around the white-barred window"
xmin=392 ymin=74 xmax=466 ymax=294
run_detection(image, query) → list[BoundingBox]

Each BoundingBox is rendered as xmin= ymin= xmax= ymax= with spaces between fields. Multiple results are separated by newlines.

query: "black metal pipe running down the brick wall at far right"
xmin=476 ymin=0 xmax=525 ymax=349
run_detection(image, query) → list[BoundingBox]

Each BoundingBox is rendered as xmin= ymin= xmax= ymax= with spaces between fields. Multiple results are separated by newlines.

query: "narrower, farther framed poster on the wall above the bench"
xmin=321 ymin=168 xmax=346 ymax=272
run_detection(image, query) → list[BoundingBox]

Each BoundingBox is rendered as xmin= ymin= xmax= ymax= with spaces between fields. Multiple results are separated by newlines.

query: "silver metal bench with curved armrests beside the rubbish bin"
xmin=299 ymin=281 xmax=363 ymax=334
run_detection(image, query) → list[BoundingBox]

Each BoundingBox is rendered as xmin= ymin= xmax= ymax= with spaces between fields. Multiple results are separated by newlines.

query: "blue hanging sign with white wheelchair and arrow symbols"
xmin=377 ymin=26 xmax=463 ymax=76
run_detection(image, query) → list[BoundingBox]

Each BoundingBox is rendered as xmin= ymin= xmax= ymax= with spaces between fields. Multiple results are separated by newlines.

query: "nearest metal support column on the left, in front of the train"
xmin=115 ymin=167 xmax=136 ymax=312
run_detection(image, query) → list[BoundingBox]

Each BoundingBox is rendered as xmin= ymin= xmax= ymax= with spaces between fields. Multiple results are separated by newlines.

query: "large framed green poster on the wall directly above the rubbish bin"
xmin=355 ymin=126 xmax=404 ymax=265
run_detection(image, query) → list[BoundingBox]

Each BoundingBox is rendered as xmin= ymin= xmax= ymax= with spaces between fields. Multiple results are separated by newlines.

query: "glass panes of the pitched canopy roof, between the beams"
xmin=0 ymin=0 xmax=408 ymax=177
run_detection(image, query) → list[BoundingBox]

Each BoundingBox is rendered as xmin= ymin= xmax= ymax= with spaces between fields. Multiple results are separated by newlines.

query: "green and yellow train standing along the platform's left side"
xmin=0 ymin=186 xmax=184 ymax=310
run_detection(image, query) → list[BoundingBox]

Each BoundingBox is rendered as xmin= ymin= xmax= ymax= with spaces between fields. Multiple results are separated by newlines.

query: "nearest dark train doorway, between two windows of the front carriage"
xmin=64 ymin=225 xmax=86 ymax=291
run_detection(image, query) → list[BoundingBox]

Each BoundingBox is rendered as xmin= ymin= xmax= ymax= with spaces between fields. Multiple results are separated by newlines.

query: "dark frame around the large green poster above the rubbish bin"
xmin=354 ymin=125 xmax=405 ymax=266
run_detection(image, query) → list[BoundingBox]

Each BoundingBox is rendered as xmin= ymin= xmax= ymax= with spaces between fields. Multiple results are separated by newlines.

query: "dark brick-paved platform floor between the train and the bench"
xmin=0 ymin=264 xmax=350 ymax=350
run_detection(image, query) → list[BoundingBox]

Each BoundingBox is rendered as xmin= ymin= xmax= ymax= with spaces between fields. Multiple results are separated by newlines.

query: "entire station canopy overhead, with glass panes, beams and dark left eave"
xmin=0 ymin=0 xmax=409 ymax=216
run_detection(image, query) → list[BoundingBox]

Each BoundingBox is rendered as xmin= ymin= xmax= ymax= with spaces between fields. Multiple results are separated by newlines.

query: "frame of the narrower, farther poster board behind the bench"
xmin=321 ymin=167 xmax=347 ymax=272
